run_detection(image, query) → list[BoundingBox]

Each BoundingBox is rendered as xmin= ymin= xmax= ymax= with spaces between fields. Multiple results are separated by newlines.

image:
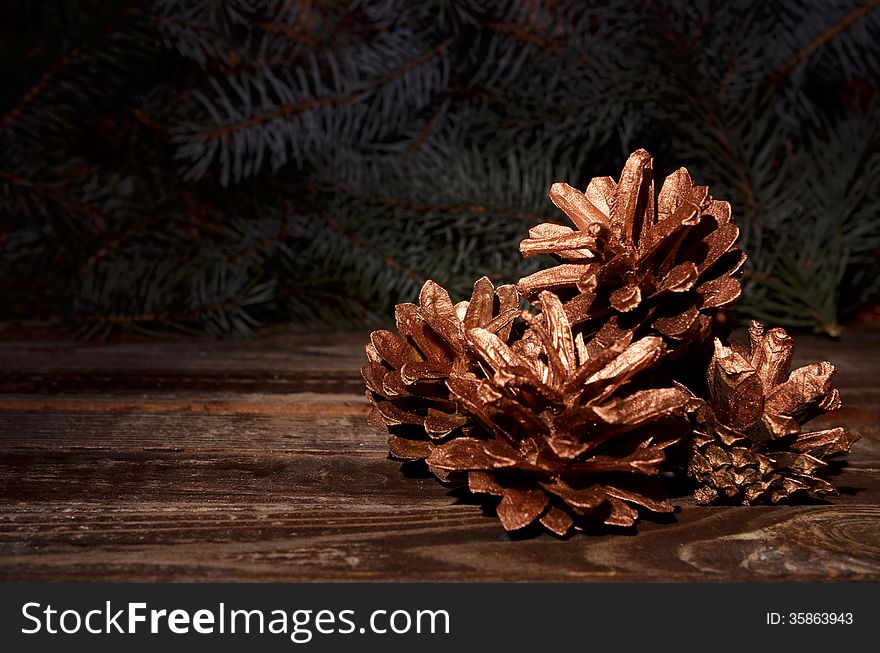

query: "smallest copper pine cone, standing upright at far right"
xmin=688 ymin=322 xmax=858 ymax=505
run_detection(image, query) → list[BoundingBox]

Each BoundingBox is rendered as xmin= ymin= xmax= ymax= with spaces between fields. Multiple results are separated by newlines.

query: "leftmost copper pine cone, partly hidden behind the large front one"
xmin=361 ymin=277 xmax=520 ymax=460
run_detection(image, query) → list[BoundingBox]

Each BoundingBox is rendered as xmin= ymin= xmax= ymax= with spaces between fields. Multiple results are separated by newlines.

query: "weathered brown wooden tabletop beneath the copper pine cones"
xmin=0 ymin=327 xmax=880 ymax=582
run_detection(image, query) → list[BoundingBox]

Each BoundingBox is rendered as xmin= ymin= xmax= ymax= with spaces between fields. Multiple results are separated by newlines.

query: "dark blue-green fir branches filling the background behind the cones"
xmin=0 ymin=0 xmax=880 ymax=336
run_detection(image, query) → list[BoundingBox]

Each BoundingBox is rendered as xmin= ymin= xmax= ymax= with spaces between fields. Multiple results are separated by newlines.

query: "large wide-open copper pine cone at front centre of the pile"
xmin=427 ymin=292 xmax=689 ymax=536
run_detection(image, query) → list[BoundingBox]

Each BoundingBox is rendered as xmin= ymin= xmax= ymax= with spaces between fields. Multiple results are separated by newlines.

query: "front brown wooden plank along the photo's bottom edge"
xmin=0 ymin=441 xmax=880 ymax=581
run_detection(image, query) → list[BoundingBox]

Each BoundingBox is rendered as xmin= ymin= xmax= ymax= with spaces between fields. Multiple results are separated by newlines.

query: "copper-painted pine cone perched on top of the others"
xmin=518 ymin=150 xmax=746 ymax=348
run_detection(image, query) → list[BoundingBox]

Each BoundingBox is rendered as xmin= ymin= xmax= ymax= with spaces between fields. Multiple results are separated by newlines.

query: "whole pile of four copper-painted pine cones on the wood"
xmin=362 ymin=150 xmax=857 ymax=536
